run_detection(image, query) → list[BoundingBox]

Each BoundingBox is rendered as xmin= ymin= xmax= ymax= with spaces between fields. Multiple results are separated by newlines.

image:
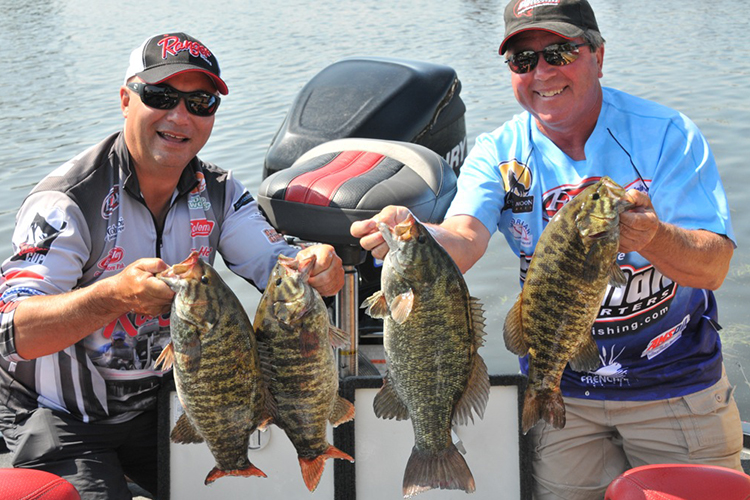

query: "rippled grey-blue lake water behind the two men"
xmin=0 ymin=0 xmax=750 ymax=420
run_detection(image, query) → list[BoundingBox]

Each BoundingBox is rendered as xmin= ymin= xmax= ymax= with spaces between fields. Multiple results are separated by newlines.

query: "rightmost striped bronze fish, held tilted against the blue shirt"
xmin=503 ymin=177 xmax=630 ymax=433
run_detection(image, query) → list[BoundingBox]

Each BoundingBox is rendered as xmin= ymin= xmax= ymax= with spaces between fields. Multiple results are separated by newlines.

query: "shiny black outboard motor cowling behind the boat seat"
xmin=263 ymin=57 xmax=466 ymax=179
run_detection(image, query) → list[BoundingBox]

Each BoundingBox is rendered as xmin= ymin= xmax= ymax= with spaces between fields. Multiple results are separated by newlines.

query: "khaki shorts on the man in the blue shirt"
xmin=529 ymin=374 xmax=742 ymax=500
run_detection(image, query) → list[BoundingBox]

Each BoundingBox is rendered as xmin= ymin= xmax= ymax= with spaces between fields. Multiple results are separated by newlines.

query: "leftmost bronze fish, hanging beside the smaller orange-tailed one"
xmin=156 ymin=252 xmax=267 ymax=484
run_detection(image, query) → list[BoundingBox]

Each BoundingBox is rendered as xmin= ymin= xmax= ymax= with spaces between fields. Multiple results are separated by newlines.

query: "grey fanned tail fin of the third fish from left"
xmin=403 ymin=443 xmax=476 ymax=498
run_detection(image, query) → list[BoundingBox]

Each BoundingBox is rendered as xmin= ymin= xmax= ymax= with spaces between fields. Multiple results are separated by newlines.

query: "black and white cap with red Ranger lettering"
xmin=125 ymin=33 xmax=229 ymax=95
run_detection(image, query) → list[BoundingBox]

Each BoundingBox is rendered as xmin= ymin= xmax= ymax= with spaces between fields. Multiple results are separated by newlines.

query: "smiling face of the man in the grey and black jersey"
xmin=120 ymin=71 xmax=216 ymax=173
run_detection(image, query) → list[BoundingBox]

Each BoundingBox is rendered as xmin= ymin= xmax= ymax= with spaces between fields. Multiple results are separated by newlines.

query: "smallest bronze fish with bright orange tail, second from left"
xmin=254 ymin=255 xmax=354 ymax=491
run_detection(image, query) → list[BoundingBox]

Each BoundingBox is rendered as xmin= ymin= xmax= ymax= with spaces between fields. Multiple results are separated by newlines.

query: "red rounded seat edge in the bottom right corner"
xmin=604 ymin=464 xmax=750 ymax=500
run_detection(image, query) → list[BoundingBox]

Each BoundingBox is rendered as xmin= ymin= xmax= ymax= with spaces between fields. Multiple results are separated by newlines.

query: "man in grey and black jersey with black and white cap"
xmin=0 ymin=33 xmax=344 ymax=500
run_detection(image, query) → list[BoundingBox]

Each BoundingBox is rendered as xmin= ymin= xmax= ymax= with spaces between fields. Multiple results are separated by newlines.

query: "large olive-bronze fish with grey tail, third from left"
xmin=363 ymin=215 xmax=490 ymax=497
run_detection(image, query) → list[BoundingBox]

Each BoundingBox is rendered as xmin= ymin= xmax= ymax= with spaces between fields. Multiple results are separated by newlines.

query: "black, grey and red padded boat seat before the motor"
xmin=258 ymin=138 xmax=456 ymax=258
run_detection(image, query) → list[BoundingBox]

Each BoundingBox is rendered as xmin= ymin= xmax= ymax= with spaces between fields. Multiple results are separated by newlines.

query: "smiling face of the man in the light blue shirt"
xmin=507 ymin=30 xmax=604 ymax=137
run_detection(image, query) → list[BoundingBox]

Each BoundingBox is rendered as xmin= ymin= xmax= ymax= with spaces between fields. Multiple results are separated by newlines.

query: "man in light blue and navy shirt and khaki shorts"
xmin=352 ymin=0 xmax=742 ymax=500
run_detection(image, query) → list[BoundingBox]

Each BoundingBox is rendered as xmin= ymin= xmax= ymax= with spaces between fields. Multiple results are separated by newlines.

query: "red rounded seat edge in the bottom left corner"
xmin=0 ymin=468 xmax=81 ymax=500
